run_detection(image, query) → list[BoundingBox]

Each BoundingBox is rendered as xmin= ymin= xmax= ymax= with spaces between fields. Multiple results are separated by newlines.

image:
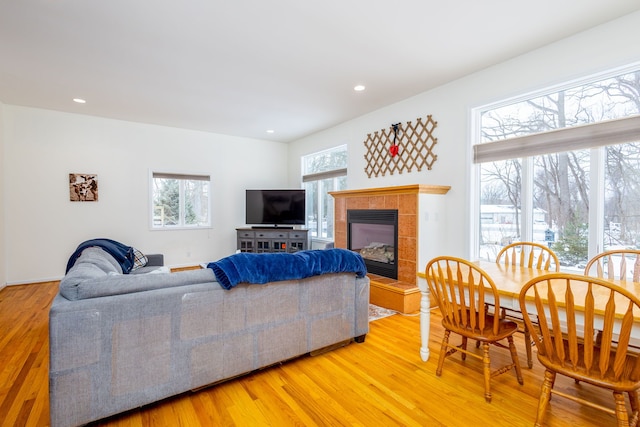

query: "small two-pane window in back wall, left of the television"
xmin=151 ymin=172 xmax=211 ymax=229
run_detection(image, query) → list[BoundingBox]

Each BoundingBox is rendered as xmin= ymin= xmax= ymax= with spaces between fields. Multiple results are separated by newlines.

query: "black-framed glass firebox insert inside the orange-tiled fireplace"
xmin=347 ymin=209 xmax=398 ymax=279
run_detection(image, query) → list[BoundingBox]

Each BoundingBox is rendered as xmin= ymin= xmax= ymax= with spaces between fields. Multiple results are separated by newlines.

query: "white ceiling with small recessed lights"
xmin=0 ymin=0 xmax=640 ymax=142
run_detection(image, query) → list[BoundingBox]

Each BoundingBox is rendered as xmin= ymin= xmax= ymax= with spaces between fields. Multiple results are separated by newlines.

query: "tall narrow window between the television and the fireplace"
xmin=302 ymin=145 xmax=347 ymax=241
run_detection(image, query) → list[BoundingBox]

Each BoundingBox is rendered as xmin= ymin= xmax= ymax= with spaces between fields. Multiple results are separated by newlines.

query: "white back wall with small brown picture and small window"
xmin=0 ymin=105 xmax=288 ymax=284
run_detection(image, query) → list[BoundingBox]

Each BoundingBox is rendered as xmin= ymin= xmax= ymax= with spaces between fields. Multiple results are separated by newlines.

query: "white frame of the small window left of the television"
xmin=149 ymin=169 xmax=213 ymax=231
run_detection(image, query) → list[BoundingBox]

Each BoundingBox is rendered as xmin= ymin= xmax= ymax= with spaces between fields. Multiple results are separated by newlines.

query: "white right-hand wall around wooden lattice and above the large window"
xmin=289 ymin=12 xmax=640 ymax=260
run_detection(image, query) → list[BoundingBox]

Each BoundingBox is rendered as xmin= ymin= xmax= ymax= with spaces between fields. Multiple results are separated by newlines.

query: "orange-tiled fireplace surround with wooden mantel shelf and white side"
xmin=329 ymin=184 xmax=451 ymax=312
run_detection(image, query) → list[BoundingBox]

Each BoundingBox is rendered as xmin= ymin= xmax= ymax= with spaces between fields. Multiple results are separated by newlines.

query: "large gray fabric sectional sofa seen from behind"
xmin=49 ymin=247 xmax=369 ymax=427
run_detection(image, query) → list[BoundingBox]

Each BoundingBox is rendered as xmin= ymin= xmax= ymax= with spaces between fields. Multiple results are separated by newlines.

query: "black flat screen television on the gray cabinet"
xmin=246 ymin=189 xmax=305 ymax=227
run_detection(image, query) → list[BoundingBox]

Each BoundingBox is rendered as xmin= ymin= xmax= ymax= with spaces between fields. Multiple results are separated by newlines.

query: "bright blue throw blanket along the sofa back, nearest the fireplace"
xmin=207 ymin=249 xmax=367 ymax=289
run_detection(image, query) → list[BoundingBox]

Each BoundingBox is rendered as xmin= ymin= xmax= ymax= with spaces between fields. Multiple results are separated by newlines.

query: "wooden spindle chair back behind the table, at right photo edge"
xmin=584 ymin=249 xmax=640 ymax=282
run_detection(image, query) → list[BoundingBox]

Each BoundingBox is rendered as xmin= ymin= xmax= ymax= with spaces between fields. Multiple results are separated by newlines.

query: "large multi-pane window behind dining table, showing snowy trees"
xmin=474 ymin=66 xmax=640 ymax=270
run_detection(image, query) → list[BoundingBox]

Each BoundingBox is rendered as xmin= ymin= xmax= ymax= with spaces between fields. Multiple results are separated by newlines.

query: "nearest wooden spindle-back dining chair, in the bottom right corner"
xmin=519 ymin=273 xmax=640 ymax=426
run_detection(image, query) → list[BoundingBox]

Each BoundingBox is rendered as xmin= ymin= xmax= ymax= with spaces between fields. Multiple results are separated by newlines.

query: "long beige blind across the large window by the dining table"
xmin=473 ymin=116 xmax=640 ymax=163
